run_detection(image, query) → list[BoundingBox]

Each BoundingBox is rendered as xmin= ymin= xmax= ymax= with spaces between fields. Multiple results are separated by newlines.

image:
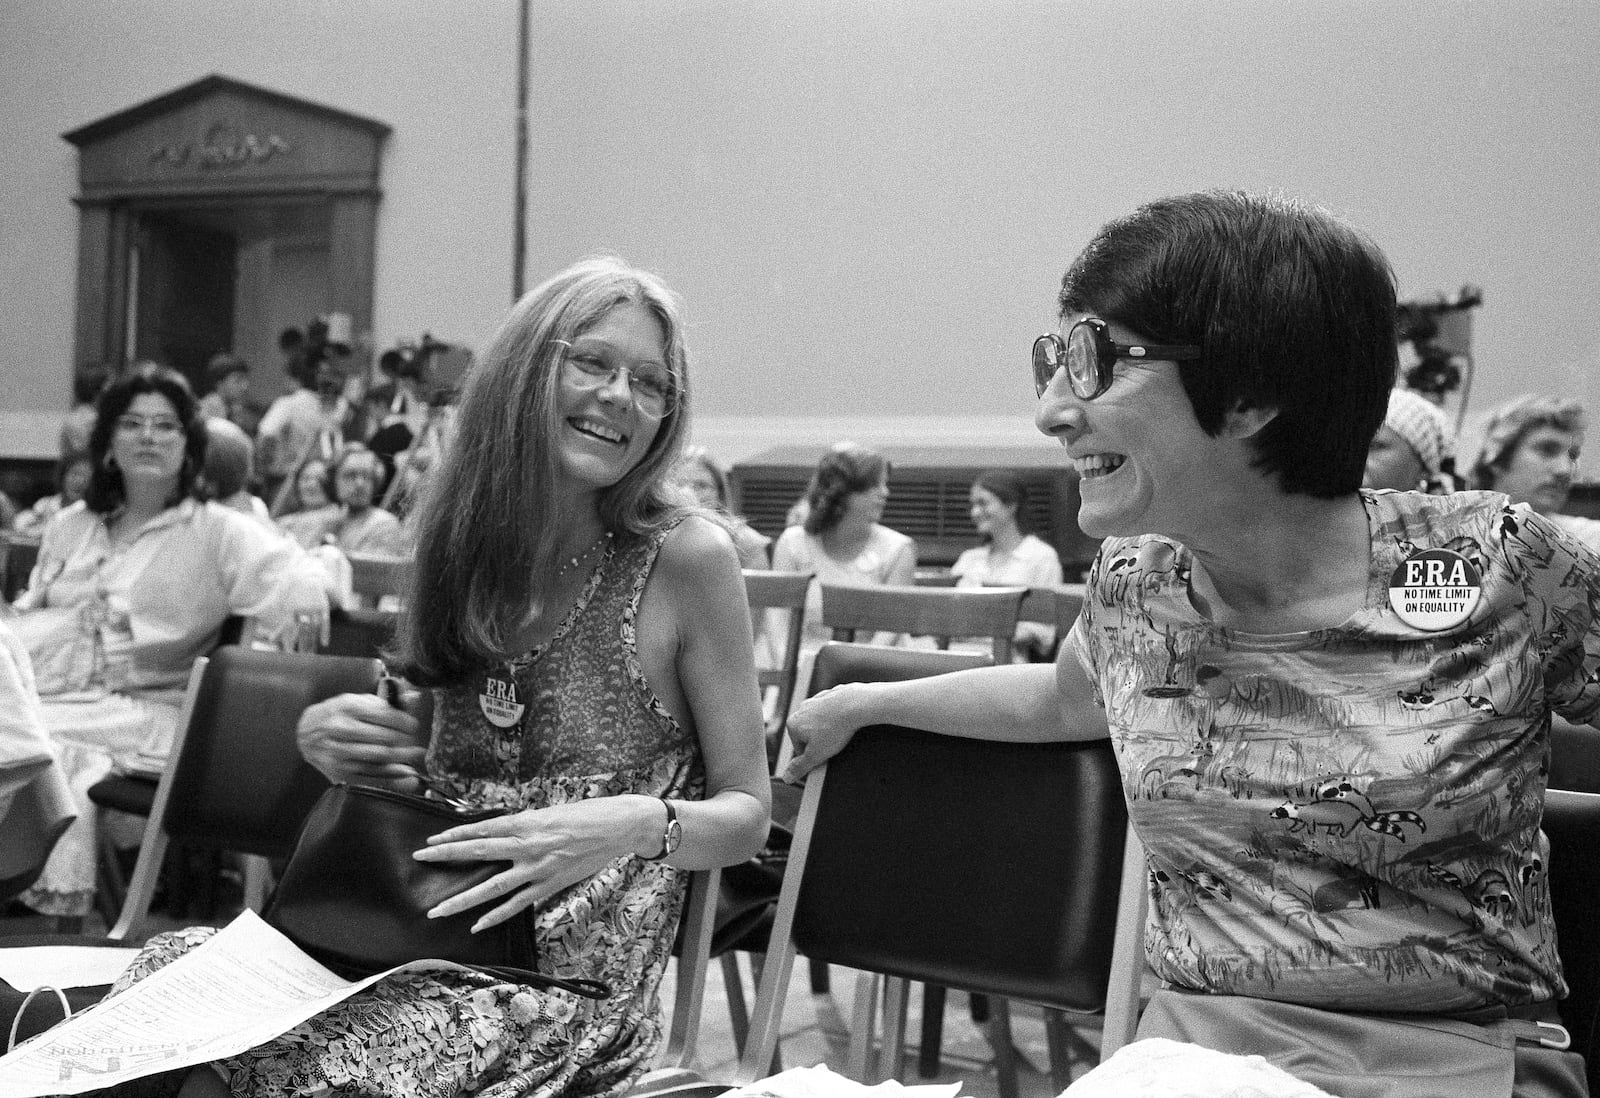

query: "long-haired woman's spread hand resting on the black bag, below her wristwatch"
xmin=413 ymin=797 xmax=659 ymax=933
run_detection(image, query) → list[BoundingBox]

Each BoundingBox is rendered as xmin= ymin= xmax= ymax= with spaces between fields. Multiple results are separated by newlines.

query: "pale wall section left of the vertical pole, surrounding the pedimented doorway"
xmin=0 ymin=0 xmax=517 ymax=455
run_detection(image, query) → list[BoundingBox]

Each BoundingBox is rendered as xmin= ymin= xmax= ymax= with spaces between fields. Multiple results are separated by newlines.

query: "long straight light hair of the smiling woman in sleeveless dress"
xmin=395 ymin=256 xmax=690 ymax=685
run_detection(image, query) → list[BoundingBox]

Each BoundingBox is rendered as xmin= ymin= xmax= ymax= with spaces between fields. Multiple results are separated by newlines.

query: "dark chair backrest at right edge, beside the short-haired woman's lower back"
xmin=1542 ymin=789 xmax=1600 ymax=1093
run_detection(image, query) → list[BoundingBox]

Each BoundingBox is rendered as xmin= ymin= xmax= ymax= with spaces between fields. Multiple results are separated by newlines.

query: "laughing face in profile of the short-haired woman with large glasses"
xmin=1034 ymin=314 xmax=1261 ymax=539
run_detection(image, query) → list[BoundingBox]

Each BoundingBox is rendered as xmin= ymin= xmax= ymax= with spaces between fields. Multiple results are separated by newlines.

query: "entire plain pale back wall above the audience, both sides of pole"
xmin=0 ymin=0 xmax=1600 ymax=459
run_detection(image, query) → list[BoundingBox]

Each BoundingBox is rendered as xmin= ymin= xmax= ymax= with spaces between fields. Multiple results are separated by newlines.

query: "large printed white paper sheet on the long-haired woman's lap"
xmin=0 ymin=911 xmax=459 ymax=1098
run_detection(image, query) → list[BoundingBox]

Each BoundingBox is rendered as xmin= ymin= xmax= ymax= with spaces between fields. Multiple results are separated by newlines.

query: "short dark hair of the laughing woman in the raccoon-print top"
xmin=1059 ymin=190 xmax=1397 ymax=498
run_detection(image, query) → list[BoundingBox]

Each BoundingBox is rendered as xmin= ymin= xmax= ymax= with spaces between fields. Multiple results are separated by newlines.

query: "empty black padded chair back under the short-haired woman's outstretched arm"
xmin=739 ymin=713 xmax=1142 ymax=1082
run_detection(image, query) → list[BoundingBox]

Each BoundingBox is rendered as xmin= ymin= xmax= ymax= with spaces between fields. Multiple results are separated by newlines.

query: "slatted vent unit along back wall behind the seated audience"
xmin=730 ymin=447 xmax=1099 ymax=583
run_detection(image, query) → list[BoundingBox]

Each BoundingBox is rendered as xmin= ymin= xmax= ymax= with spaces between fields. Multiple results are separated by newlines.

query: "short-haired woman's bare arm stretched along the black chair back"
xmin=782 ymin=645 xmax=1107 ymax=781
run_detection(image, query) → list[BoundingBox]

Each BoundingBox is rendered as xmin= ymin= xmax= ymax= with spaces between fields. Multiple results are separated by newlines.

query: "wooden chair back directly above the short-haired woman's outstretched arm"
xmin=822 ymin=583 xmax=1027 ymax=663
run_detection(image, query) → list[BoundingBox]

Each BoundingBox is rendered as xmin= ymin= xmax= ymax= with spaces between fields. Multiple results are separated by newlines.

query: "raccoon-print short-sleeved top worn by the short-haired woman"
xmin=1069 ymin=491 xmax=1600 ymax=1012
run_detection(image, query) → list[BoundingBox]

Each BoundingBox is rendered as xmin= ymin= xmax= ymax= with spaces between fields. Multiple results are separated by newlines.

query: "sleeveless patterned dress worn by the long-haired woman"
xmin=118 ymin=535 xmax=706 ymax=1098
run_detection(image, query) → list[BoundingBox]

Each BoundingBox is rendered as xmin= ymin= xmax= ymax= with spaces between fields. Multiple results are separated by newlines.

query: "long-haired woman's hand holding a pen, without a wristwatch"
xmin=294 ymin=695 xmax=427 ymax=792
